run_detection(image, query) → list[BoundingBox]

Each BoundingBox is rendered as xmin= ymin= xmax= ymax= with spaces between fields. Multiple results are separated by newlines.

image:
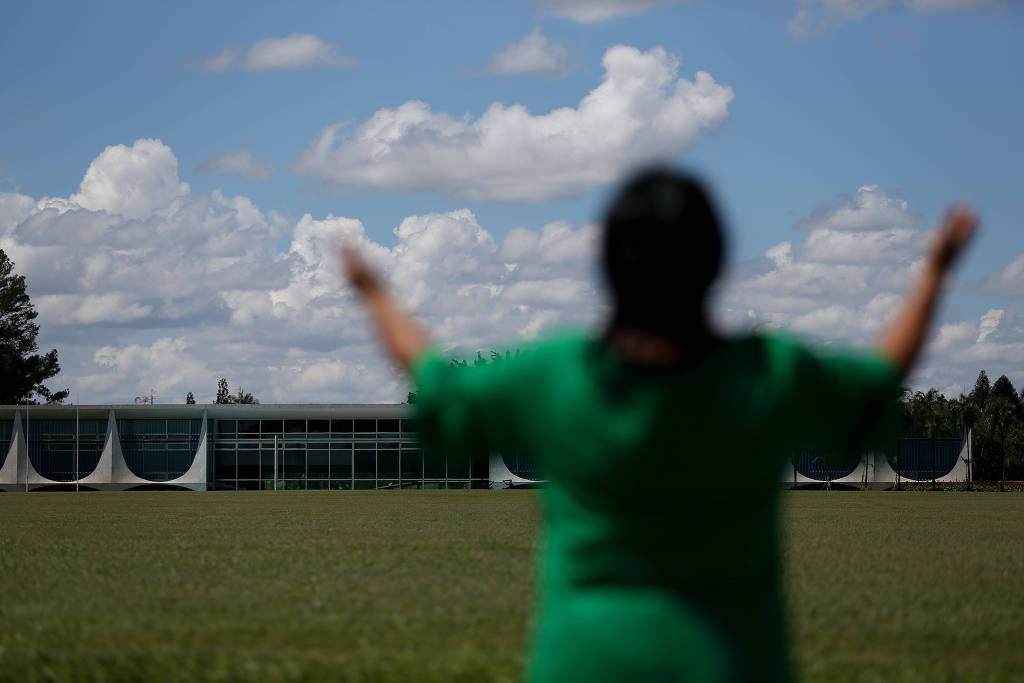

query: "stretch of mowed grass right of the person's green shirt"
xmin=783 ymin=492 xmax=1024 ymax=683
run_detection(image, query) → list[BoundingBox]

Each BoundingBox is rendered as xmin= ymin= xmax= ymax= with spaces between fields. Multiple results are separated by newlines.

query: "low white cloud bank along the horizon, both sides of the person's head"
xmin=9 ymin=140 xmax=1024 ymax=402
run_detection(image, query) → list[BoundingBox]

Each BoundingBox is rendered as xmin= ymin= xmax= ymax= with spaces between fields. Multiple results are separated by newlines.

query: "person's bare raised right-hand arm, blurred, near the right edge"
xmin=879 ymin=207 xmax=978 ymax=376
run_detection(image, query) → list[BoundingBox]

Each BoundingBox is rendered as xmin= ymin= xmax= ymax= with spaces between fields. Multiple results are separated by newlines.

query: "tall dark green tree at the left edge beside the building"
xmin=0 ymin=249 xmax=70 ymax=404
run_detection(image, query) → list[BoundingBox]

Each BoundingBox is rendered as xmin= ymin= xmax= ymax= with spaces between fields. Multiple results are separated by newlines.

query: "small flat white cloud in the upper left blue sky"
xmin=201 ymin=33 xmax=355 ymax=73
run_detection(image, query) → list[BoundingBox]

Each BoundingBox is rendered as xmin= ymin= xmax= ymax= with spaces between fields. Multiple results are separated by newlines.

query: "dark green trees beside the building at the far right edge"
xmin=901 ymin=370 xmax=1024 ymax=482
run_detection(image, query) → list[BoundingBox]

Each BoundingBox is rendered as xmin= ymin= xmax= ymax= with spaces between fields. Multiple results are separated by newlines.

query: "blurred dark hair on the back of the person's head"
xmin=603 ymin=169 xmax=725 ymax=336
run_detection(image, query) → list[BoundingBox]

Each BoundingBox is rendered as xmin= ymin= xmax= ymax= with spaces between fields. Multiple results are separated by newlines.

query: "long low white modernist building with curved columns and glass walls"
xmin=0 ymin=404 xmax=971 ymax=490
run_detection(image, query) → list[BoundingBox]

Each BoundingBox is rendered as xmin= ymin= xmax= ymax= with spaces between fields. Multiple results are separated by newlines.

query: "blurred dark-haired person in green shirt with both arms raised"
xmin=341 ymin=170 xmax=977 ymax=682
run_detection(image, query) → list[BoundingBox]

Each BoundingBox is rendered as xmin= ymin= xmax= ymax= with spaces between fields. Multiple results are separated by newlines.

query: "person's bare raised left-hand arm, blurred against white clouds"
xmin=340 ymin=244 xmax=429 ymax=371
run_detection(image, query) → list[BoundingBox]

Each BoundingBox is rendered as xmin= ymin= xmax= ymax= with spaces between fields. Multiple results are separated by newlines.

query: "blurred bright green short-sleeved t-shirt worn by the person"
xmin=413 ymin=335 xmax=899 ymax=681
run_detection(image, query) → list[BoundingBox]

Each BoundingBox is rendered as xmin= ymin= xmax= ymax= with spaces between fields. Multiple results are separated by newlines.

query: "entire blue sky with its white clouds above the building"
xmin=0 ymin=0 xmax=1024 ymax=402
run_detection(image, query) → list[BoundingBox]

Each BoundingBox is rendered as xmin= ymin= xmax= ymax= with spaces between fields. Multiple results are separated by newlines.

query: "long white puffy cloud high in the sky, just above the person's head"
xmin=292 ymin=45 xmax=733 ymax=203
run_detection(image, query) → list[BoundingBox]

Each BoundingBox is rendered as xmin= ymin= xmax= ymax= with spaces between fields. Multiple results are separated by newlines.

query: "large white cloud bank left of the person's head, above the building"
xmin=0 ymin=140 xmax=602 ymax=402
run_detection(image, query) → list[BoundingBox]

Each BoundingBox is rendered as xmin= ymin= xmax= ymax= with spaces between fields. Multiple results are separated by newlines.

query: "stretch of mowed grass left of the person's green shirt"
xmin=0 ymin=492 xmax=537 ymax=682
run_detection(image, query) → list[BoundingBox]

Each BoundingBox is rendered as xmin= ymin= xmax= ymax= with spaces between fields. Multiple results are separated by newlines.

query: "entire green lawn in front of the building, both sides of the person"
xmin=0 ymin=492 xmax=1024 ymax=682
